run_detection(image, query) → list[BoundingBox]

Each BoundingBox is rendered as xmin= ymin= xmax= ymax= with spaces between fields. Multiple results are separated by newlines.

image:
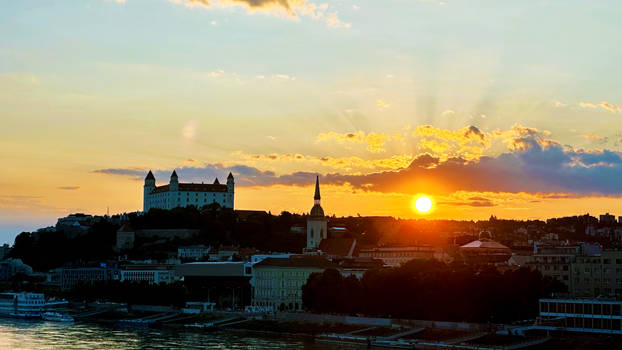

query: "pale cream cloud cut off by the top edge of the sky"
xmin=169 ymin=0 xmax=352 ymax=28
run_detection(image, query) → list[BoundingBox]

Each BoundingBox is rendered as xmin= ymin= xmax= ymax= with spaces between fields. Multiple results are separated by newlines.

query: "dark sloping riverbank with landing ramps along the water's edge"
xmin=72 ymin=308 xmax=548 ymax=349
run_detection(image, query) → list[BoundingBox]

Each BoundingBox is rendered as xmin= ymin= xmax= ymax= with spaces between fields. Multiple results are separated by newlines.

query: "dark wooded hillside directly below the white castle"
xmin=10 ymin=204 xmax=306 ymax=271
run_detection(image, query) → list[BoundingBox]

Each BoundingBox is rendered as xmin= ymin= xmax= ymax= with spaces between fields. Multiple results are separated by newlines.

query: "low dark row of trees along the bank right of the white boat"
xmin=64 ymin=281 xmax=187 ymax=307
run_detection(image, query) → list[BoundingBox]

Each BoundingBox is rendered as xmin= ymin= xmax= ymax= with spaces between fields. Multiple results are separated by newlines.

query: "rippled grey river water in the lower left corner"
xmin=0 ymin=318 xmax=361 ymax=350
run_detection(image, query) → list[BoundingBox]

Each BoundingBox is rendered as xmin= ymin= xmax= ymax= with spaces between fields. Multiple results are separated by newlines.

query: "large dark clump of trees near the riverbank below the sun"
xmin=302 ymin=260 xmax=565 ymax=322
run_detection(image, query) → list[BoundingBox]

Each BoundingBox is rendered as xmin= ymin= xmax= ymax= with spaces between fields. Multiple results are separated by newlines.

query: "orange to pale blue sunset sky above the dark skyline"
xmin=0 ymin=0 xmax=622 ymax=243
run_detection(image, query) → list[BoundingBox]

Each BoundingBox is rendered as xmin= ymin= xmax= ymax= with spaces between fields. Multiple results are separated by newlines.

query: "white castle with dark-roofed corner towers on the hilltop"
xmin=143 ymin=170 xmax=234 ymax=212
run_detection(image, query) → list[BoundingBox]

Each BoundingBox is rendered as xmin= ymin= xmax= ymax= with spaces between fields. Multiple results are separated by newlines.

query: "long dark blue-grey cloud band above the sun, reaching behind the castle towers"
xmin=95 ymin=135 xmax=622 ymax=196
